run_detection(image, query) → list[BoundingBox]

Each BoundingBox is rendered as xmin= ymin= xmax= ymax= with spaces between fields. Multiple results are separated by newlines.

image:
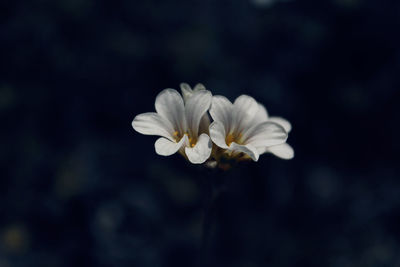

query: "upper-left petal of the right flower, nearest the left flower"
xmin=210 ymin=95 xmax=233 ymax=132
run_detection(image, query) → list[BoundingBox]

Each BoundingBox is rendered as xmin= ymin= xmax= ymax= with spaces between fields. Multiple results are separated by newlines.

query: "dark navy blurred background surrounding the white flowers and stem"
xmin=0 ymin=0 xmax=400 ymax=267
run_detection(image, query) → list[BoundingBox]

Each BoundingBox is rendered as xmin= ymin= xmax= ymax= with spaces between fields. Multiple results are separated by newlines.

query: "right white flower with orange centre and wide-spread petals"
xmin=210 ymin=95 xmax=290 ymax=161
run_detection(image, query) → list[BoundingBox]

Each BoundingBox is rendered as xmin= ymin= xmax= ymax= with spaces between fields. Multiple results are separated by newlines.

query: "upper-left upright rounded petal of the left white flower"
xmin=155 ymin=89 xmax=187 ymax=134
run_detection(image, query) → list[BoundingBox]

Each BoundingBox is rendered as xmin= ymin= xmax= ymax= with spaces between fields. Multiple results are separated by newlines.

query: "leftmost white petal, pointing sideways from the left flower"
xmin=132 ymin=112 xmax=174 ymax=140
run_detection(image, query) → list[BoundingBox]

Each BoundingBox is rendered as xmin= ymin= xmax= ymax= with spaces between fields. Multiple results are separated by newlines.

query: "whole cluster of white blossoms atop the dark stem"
xmin=132 ymin=83 xmax=294 ymax=166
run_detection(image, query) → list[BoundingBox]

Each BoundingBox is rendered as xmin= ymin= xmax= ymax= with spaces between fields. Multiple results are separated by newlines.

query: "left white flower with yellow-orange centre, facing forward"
xmin=132 ymin=87 xmax=212 ymax=164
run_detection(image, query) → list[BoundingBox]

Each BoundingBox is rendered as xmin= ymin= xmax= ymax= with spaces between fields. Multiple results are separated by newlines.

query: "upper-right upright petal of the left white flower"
xmin=185 ymin=90 xmax=212 ymax=137
